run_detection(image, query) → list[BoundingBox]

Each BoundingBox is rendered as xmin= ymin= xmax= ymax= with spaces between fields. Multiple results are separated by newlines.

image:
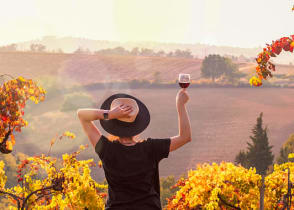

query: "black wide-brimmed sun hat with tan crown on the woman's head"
xmin=100 ymin=93 xmax=150 ymax=137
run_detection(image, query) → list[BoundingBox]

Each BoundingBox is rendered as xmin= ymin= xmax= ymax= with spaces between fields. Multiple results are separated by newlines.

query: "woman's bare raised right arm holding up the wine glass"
xmin=169 ymin=89 xmax=192 ymax=152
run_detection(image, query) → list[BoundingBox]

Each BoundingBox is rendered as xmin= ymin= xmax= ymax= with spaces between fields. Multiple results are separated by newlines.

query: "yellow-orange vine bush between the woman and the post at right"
xmin=167 ymin=162 xmax=260 ymax=210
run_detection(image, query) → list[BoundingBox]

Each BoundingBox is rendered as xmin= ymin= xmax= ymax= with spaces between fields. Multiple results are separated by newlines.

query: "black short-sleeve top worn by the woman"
xmin=95 ymin=135 xmax=171 ymax=210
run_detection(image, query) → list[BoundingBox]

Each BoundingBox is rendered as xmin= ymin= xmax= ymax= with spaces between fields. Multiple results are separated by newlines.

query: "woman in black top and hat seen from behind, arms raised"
xmin=77 ymin=89 xmax=191 ymax=210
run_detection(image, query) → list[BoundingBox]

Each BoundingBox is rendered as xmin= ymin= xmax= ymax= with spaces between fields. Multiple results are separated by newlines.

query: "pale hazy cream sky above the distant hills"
xmin=0 ymin=0 xmax=294 ymax=47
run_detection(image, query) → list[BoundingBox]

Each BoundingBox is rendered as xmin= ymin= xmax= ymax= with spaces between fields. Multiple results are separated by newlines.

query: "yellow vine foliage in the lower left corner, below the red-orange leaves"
xmin=0 ymin=132 xmax=107 ymax=210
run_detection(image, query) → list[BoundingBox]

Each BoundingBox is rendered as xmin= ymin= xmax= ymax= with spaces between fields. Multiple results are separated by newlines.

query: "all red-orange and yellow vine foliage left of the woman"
xmin=0 ymin=75 xmax=107 ymax=209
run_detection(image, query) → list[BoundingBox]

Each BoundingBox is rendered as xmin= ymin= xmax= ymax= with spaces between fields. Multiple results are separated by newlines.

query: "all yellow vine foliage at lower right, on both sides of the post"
xmin=166 ymin=162 xmax=294 ymax=209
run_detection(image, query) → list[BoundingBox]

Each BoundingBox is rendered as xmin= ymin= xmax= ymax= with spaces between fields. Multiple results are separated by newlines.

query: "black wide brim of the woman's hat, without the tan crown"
xmin=100 ymin=93 xmax=150 ymax=137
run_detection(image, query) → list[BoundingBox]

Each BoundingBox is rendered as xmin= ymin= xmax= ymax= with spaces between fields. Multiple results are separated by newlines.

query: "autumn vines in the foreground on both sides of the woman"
xmin=0 ymin=74 xmax=294 ymax=209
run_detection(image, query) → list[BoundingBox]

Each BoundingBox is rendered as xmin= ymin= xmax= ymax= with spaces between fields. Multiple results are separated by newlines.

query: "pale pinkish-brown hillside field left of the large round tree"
xmin=0 ymin=52 xmax=202 ymax=85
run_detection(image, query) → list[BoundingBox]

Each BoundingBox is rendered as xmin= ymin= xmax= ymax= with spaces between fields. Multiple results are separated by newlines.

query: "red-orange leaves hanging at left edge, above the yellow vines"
xmin=0 ymin=75 xmax=46 ymax=154
